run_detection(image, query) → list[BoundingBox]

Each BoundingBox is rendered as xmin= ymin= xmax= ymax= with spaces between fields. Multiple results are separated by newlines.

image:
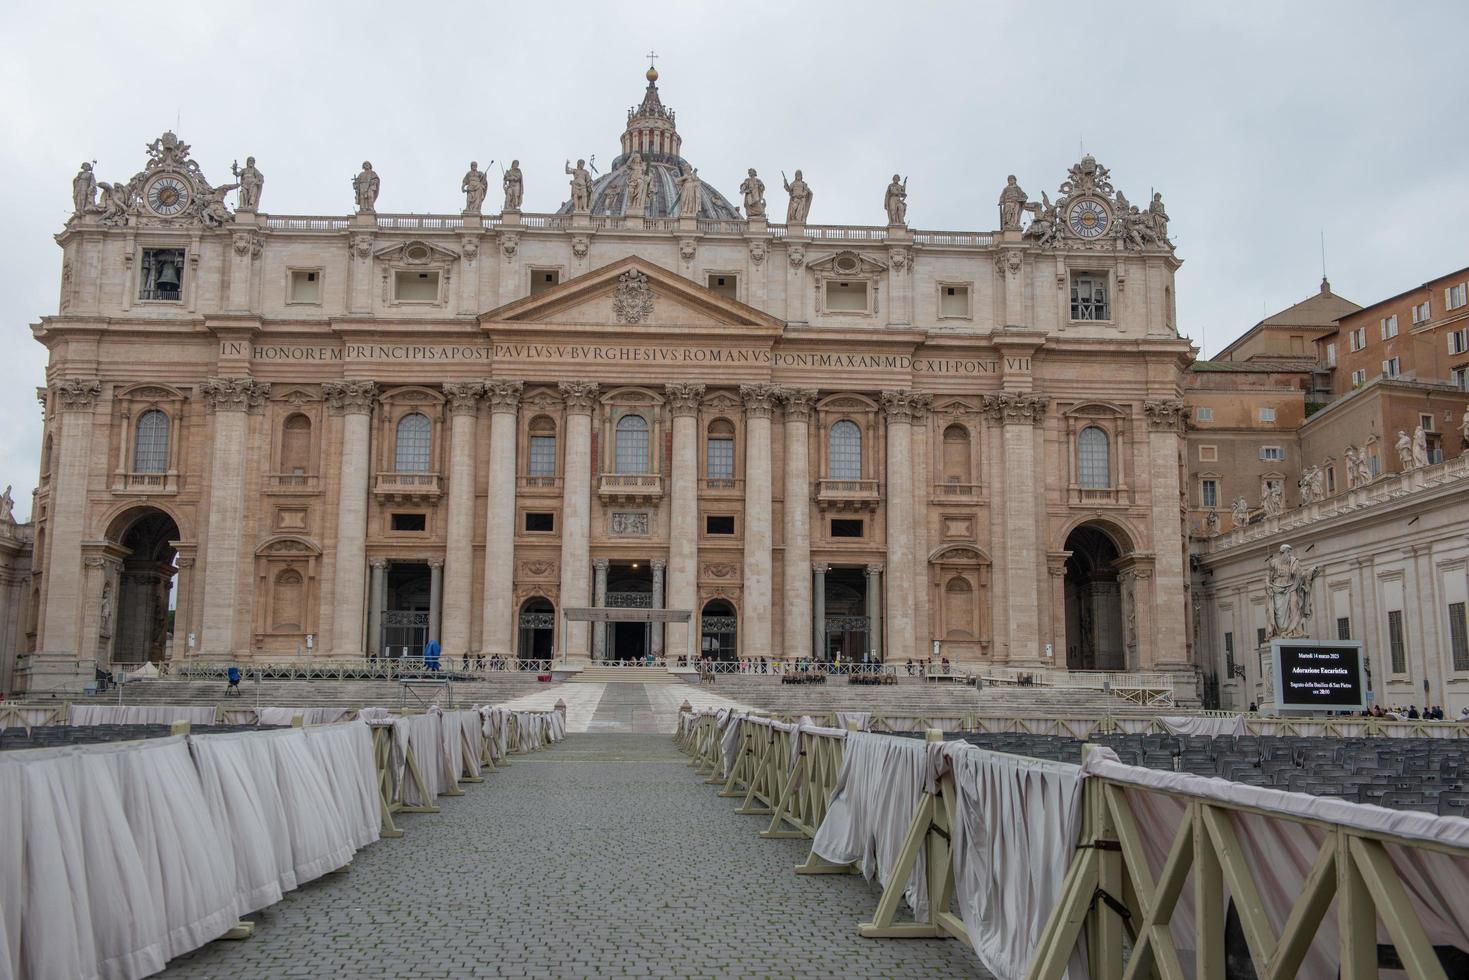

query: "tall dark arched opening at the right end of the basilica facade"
xmin=1066 ymin=525 xmax=1127 ymax=670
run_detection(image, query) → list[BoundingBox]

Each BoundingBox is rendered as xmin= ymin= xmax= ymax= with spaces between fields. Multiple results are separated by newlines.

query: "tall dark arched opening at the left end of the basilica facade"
xmin=105 ymin=507 xmax=179 ymax=664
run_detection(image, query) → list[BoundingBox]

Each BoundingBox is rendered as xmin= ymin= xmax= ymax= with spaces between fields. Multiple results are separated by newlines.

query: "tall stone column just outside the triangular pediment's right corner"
xmin=780 ymin=388 xmax=817 ymax=658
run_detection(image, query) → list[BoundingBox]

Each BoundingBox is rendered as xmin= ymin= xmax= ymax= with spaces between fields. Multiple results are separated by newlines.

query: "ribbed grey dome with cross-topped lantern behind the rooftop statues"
xmin=557 ymin=69 xmax=740 ymax=220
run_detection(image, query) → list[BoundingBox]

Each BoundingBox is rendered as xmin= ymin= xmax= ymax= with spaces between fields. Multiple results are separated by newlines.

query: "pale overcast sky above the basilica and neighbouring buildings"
xmin=0 ymin=0 xmax=1469 ymax=519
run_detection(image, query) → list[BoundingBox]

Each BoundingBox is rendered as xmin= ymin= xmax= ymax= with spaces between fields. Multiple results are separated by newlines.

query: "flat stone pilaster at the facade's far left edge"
xmin=31 ymin=379 xmax=102 ymax=664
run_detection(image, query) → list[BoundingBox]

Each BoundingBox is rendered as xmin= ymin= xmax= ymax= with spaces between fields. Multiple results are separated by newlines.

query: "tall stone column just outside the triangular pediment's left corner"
xmin=438 ymin=381 xmax=485 ymax=658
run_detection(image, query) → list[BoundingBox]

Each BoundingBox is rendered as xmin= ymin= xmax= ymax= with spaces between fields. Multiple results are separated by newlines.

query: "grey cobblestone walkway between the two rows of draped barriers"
xmin=163 ymin=731 xmax=984 ymax=977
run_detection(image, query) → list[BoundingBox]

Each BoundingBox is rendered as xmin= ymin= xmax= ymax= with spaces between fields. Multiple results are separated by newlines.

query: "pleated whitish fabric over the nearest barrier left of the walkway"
xmin=0 ymin=723 xmax=379 ymax=980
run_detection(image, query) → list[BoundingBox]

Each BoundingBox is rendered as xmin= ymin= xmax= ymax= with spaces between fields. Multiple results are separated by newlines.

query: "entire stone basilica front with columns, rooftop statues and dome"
xmin=18 ymin=72 xmax=1193 ymax=689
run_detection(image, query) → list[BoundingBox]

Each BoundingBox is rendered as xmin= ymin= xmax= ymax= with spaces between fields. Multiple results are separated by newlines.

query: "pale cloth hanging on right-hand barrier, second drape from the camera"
xmin=811 ymin=732 xmax=928 ymax=921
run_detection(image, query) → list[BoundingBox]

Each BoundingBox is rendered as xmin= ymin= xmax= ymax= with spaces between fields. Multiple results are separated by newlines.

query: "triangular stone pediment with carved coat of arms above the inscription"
xmin=479 ymin=256 xmax=784 ymax=332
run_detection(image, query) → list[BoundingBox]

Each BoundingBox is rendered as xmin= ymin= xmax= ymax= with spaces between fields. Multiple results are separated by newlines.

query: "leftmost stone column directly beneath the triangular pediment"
xmin=480 ymin=381 xmax=522 ymax=657
